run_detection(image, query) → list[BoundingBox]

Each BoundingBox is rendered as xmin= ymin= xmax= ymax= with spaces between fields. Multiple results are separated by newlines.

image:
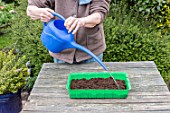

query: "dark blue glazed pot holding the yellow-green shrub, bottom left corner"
xmin=0 ymin=91 xmax=22 ymax=113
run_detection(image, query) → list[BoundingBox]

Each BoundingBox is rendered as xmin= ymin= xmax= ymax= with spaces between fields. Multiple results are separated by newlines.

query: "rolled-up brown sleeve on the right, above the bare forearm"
xmin=90 ymin=0 xmax=111 ymax=22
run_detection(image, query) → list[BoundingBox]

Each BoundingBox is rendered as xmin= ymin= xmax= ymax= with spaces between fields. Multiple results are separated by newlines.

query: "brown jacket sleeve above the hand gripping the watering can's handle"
xmin=28 ymin=0 xmax=55 ymax=9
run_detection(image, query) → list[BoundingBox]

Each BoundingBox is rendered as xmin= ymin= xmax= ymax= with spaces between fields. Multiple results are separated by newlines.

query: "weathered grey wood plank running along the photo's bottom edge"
xmin=24 ymin=103 xmax=170 ymax=113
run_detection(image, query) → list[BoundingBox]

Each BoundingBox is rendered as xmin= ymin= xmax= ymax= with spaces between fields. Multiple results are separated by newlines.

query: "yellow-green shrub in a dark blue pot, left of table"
xmin=0 ymin=50 xmax=27 ymax=113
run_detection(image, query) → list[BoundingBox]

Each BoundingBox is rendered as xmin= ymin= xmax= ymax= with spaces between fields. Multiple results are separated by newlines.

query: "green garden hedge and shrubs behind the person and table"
xmin=0 ymin=0 xmax=170 ymax=91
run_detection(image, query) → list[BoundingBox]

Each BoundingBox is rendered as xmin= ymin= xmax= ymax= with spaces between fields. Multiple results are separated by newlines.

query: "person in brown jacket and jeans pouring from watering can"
xmin=27 ymin=0 xmax=110 ymax=63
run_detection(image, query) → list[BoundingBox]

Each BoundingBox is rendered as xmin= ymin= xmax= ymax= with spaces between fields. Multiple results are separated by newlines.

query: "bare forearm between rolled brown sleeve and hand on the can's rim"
xmin=81 ymin=12 xmax=101 ymax=28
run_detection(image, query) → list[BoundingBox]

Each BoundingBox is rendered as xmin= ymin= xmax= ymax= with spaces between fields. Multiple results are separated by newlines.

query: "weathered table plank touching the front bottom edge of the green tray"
xmin=26 ymin=95 xmax=170 ymax=104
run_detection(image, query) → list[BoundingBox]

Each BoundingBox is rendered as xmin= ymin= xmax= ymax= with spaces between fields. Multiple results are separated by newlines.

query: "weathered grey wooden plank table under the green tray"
xmin=22 ymin=61 xmax=170 ymax=113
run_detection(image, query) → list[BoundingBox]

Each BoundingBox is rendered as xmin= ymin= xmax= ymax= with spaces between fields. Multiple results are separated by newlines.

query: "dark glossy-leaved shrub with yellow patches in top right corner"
xmin=117 ymin=0 xmax=170 ymax=35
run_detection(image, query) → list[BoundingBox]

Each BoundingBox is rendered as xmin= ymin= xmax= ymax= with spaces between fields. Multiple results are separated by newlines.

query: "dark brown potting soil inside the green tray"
xmin=71 ymin=77 xmax=126 ymax=89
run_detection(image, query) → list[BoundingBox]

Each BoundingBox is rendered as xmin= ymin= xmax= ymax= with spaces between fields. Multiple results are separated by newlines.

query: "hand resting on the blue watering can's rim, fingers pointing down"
xmin=64 ymin=16 xmax=85 ymax=34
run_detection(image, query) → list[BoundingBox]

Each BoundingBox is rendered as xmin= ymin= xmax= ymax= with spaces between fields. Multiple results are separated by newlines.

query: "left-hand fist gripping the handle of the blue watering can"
xmin=39 ymin=8 xmax=54 ymax=22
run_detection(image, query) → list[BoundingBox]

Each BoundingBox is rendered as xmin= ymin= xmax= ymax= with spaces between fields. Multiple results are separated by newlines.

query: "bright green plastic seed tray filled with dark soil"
xmin=66 ymin=72 xmax=131 ymax=98
